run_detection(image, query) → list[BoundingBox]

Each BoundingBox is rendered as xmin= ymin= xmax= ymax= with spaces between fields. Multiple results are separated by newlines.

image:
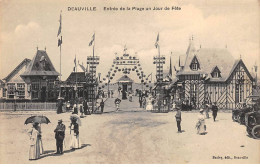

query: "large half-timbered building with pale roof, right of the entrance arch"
xmin=172 ymin=40 xmax=254 ymax=109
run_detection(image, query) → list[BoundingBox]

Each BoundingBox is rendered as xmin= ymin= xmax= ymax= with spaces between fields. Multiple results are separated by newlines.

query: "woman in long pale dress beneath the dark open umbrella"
xmin=28 ymin=123 xmax=40 ymax=160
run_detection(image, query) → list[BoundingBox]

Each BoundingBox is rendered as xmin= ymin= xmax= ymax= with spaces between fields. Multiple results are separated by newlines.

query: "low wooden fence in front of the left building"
xmin=0 ymin=102 xmax=57 ymax=111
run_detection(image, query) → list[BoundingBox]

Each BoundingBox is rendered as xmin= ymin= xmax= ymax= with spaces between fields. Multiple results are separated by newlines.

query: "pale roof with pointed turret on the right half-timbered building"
xmin=177 ymin=41 xmax=236 ymax=81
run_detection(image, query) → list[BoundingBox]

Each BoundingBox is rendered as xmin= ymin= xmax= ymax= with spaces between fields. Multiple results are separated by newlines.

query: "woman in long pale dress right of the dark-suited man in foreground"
xmin=70 ymin=119 xmax=81 ymax=149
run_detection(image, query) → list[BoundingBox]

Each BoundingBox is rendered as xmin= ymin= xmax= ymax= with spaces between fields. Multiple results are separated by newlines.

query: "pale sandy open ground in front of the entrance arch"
xmin=0 ymin=95 xmax=260 ymax=164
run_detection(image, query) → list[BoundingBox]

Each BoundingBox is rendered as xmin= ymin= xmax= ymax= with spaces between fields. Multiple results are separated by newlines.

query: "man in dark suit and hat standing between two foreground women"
xmin=54 ymin=120 xmax=66 ymax=154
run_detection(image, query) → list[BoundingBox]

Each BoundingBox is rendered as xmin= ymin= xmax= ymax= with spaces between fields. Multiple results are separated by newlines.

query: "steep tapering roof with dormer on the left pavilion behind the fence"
xmin=21 ymin=50 xmax=59 ymax=76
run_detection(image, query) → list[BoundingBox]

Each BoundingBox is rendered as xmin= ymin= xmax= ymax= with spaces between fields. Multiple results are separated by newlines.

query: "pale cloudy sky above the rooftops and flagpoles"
xmin=0 ymin=0 xmax=260 ymax=82
